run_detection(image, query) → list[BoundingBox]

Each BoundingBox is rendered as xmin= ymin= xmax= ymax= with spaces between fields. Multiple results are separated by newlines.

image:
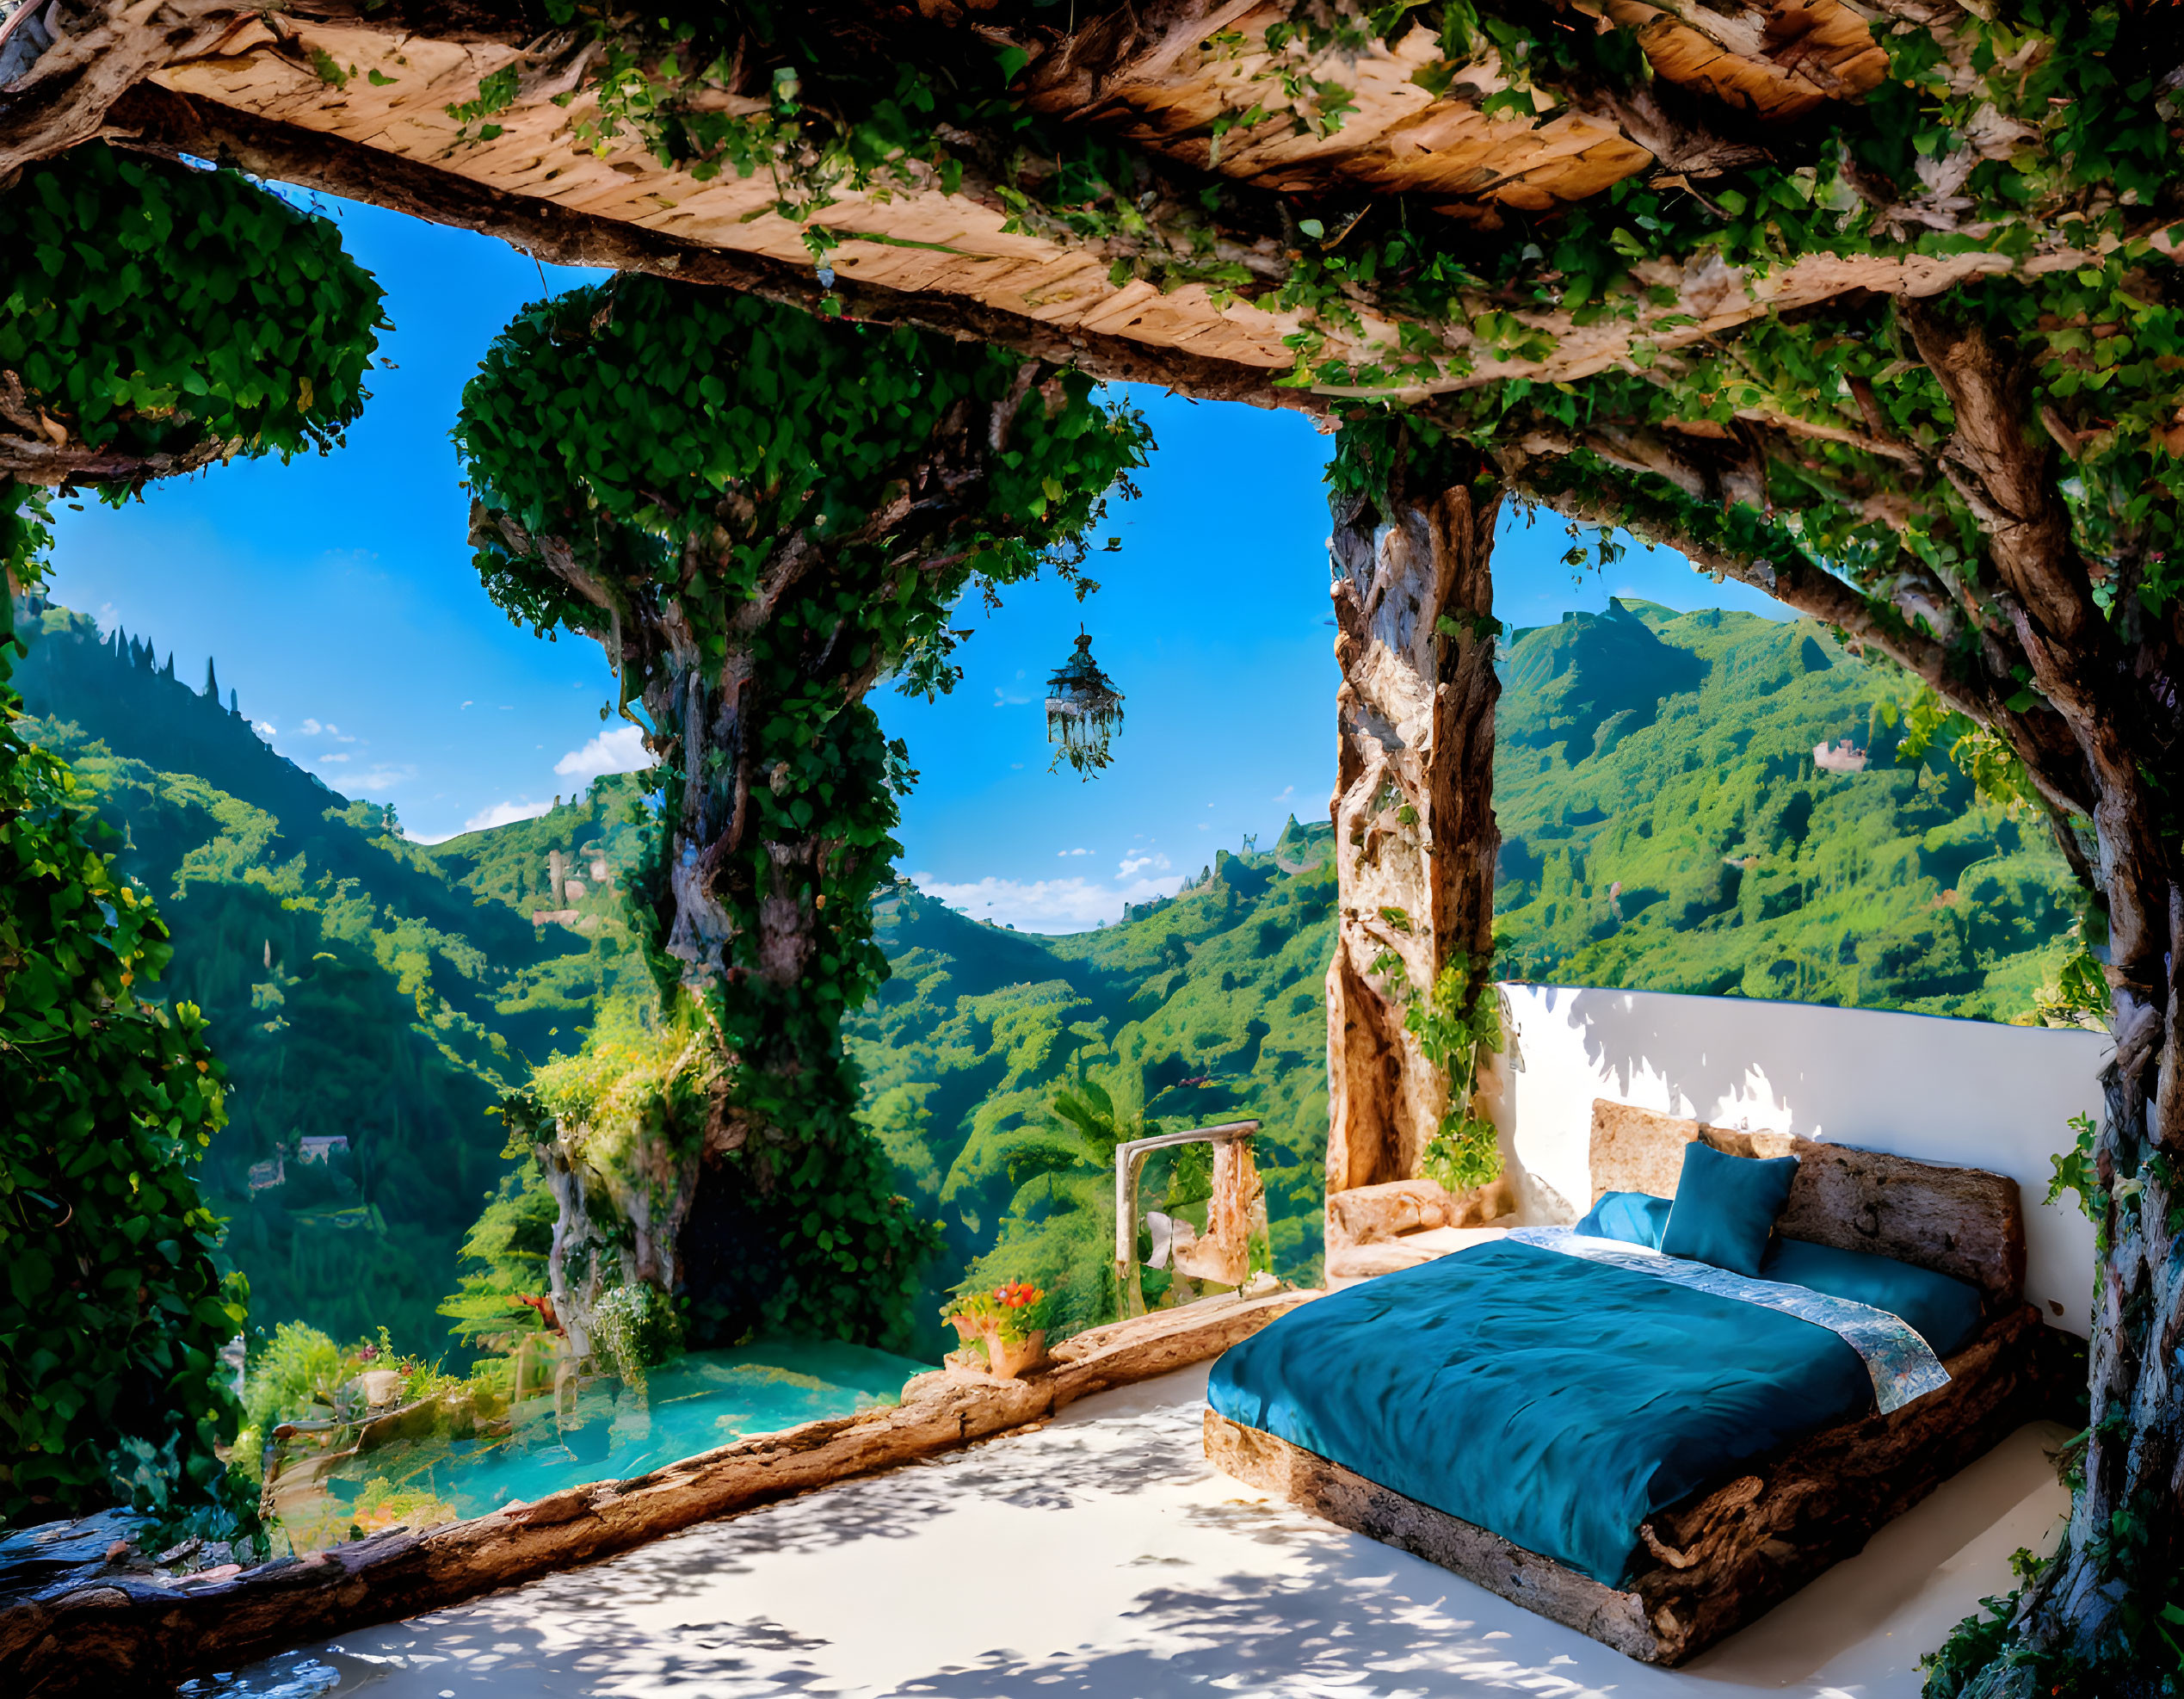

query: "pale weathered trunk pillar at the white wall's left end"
xmin=1328 ymin=432 xmax=1501 ymax=1192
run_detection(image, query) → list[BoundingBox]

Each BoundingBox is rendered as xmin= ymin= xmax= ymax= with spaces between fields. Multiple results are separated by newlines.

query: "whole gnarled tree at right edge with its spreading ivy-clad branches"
xmin=1498 ymin=307 xmax=2184 ymax=1699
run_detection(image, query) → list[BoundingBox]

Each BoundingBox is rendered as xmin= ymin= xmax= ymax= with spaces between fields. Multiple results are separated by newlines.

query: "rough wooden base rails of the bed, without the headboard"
xmin=1206 ymin=1306 xmax=2068 ymax=1664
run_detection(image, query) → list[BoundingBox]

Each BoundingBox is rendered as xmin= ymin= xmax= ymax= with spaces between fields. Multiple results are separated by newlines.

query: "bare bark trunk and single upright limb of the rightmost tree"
xmin=1907 ymin=308 xmax=2184 ymax=1695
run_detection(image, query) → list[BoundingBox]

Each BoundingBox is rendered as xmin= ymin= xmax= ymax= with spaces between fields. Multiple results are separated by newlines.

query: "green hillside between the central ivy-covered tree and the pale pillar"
xmin=848 ymin=821 xmax=1335 ymax=1343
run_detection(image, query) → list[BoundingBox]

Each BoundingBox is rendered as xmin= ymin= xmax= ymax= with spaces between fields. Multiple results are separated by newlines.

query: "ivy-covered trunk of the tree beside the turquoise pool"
xmin=474 ymin=495 xmax=935 ymax=1350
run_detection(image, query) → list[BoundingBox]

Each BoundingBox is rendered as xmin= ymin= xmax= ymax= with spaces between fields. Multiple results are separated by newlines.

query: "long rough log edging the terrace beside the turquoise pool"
xmin=0 ymin=1291 xmax=1319 ymax=1699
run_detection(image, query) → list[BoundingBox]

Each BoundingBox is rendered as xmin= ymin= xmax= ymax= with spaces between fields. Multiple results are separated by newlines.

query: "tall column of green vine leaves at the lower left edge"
xmin=0 ymin=509 xmax=253 ymax=1537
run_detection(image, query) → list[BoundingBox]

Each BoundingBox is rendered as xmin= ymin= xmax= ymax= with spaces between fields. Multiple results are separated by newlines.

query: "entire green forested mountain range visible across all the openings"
xmin=3 ymin=602 xmax=2075 ymax=1352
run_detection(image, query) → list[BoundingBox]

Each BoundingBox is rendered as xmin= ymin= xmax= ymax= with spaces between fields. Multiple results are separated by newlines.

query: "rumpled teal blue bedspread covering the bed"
xmin=1206 ymin=1243 xmax=1874 ymax=1585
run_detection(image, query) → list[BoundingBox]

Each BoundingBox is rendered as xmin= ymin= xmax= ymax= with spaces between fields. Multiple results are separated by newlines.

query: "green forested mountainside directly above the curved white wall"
xmin=1494 ymin=602 xmax=2075 ymax=1020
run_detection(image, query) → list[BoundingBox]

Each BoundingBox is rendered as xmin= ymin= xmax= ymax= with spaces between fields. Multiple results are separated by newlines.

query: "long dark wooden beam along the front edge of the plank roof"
xmin=105 ymin=83 xmax=1330 ymax=417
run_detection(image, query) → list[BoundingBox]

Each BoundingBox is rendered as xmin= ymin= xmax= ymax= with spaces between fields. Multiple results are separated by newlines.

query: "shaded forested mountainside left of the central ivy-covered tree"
xmin=15 ymin=609 xmax=636 ymax=1350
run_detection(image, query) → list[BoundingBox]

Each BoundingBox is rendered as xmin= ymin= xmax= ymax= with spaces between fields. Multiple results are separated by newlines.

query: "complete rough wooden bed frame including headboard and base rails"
xmin=1206 ymin=1101 xmax=2073 ymax=1664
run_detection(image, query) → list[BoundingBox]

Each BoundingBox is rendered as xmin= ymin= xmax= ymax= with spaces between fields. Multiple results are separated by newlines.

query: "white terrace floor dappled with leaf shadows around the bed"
xmin=192 ymin=1367 xmax=2066 ymax=1699
